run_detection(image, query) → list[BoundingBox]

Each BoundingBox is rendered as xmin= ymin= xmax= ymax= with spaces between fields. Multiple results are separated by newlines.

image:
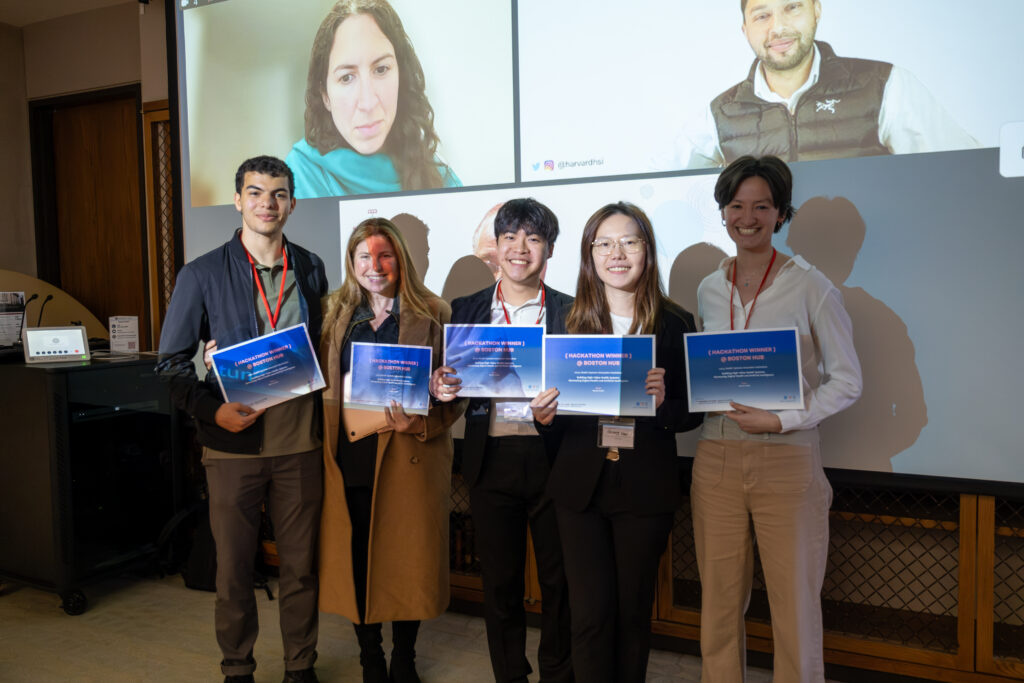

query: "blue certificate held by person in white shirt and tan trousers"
xmin=685 ymin=328 xmax=804 ymax=413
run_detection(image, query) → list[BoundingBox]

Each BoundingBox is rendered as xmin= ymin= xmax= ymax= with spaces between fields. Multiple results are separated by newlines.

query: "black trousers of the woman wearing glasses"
xmin=556 ymin=452 xmax=675 ymax=683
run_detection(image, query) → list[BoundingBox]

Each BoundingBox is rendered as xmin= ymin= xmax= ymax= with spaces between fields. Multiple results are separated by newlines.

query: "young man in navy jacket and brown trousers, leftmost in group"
xmin=157 ymin=157 xmax=327 ymax=683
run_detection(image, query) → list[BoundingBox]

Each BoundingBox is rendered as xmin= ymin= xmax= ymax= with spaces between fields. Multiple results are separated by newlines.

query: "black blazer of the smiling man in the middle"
xmin=452 ymin=285 xmax=572 ymax=486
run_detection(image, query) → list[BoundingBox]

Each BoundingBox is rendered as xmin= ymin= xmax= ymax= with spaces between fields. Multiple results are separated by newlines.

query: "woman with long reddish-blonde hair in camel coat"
xmin=319 ymin=218 xmax=463 ymax=683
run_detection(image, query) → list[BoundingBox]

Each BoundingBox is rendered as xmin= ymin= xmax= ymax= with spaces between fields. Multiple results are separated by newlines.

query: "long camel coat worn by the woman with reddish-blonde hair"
xmin=319 ymin=298 xmax=466 ymax=624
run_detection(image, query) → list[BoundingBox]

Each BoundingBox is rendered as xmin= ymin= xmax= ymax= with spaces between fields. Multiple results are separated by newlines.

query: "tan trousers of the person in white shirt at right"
xmin=690 ymin=416 xmax=831 ymax=683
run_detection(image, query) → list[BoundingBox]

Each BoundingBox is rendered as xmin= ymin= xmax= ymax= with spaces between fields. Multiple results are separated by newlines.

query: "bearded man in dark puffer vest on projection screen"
xmin=672 ymin=0 xmax=979 ymax=168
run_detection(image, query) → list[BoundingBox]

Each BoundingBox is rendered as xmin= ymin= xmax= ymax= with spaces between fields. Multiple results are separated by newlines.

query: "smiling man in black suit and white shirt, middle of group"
xmin=430 ymin=199 xmax=574 ymax=683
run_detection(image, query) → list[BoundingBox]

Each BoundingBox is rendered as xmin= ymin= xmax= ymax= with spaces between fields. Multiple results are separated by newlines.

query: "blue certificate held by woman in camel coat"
xmin=345 ymin=342 xmax=433 ymax=415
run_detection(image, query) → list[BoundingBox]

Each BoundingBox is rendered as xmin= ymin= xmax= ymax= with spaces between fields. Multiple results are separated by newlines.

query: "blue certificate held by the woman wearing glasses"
xmin=544 ymin=335 xmax=654 ymax=416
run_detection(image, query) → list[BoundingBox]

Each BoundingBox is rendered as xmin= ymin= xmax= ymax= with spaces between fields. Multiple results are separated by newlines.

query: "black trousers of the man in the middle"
xmin=469 ymin=436 xmax=574 ymax=683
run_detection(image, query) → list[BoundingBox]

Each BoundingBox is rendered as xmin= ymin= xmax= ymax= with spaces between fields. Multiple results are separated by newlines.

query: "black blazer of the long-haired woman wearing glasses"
xmin=542 ymin=301 xmax=703 ymax=514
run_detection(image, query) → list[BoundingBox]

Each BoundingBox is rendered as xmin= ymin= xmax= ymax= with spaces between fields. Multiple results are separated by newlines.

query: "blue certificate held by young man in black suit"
xmin=444 ymin=325 xmax=544 ymax=398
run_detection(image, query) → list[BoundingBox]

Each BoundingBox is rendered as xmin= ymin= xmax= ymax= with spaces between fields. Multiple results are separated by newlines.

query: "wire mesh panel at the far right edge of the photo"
xmin=992 ymin=499 xmax=1024 ymax=661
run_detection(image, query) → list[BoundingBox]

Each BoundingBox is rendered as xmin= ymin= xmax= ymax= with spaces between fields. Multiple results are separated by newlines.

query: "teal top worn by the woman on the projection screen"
xmin=285 ymin=138 xmax=462 ymax=200
